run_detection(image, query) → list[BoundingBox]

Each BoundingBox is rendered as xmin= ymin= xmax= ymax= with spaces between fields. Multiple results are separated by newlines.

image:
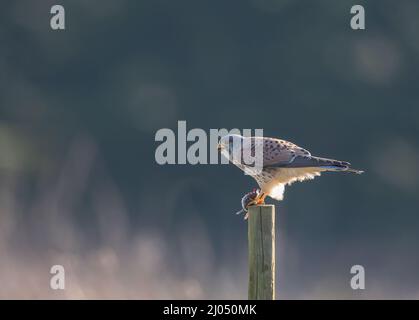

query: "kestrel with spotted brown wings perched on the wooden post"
xmin=218 ymin=134 xmax=363 ymax=204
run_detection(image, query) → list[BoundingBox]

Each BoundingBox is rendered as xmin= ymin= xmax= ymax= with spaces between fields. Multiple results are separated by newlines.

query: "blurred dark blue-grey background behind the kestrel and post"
xmin=0 ymin=0 xmax=419 ymax=299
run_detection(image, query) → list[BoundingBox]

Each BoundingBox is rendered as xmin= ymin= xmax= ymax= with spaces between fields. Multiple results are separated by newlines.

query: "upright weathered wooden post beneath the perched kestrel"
xmin=248 ymin=205 xmax=275 ymax=300
